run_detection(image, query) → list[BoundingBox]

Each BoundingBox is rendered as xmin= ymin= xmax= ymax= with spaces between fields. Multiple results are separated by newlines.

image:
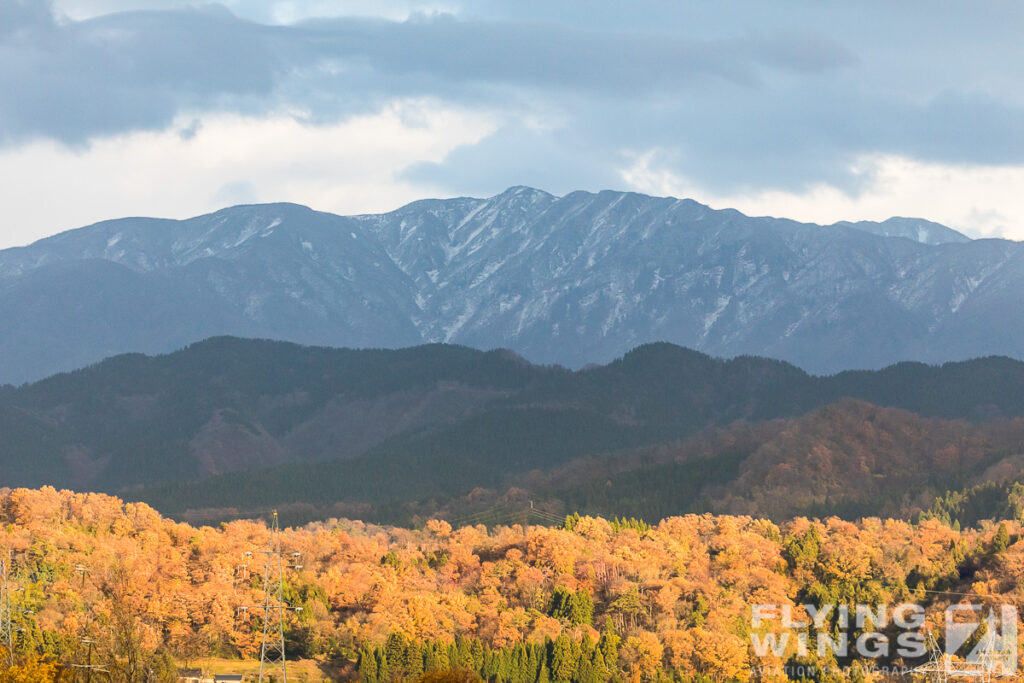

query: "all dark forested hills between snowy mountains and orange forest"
xmin=6 ymin=337 xmax=1024 ymax=522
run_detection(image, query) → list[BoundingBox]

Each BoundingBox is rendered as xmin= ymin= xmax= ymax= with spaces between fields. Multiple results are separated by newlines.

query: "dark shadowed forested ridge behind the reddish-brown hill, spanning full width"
xmin=0 ymin=338 xmax=1024 ymax=520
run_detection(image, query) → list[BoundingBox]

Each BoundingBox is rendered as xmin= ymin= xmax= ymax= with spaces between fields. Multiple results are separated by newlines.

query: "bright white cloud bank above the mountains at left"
xmin=0 ymin=99 xmax=497 ymax=248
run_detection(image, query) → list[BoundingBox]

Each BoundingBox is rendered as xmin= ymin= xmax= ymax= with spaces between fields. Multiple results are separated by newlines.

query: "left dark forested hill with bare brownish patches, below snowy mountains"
xmin=0 ymin=338 xmax=565 ymax=490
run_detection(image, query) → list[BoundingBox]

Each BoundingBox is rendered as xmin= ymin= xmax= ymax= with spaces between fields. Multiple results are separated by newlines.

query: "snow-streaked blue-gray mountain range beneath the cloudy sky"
xmin=0 ymin=187 xmax=1024 ymax=382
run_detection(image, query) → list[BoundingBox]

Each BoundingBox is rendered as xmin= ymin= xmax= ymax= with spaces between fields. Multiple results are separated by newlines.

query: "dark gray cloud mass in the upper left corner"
xmin=0 ymin=5 xmax=275 ymax=144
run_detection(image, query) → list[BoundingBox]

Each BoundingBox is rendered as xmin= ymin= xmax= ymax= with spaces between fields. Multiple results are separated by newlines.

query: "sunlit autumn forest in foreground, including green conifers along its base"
xmin=0 ymin=487 xmax=1024 ymax=683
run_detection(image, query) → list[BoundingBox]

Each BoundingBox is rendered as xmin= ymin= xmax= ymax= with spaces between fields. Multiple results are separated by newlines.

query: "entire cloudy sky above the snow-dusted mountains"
xmin=0 ymin=0 xmax=1024 ymax=248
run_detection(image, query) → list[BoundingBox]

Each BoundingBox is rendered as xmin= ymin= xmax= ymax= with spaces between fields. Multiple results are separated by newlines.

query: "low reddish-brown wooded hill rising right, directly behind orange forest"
xmin=140 ymin=399 xmax=1024 ymax=523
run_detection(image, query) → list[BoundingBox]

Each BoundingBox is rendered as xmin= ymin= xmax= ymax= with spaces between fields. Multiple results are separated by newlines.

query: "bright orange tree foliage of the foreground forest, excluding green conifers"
xmin=0 ymin=487 xmax=1024 ymax=681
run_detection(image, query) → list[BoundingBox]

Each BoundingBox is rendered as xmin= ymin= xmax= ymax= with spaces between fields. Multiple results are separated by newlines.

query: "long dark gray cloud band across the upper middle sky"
xmin=290 ymin=16 xmax=853 ymax=96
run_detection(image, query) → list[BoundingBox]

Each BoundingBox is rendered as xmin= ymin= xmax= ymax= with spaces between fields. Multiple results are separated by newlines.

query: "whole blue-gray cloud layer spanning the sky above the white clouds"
xmin=0 ymin=0 xmax=1024 ymax=197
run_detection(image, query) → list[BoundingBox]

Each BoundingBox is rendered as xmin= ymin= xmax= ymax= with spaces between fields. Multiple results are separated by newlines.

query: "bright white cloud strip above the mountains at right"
xmin=622 ymin=152 xmax=1024 ymax=240
